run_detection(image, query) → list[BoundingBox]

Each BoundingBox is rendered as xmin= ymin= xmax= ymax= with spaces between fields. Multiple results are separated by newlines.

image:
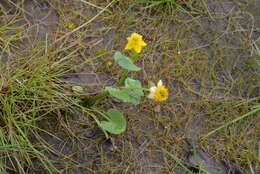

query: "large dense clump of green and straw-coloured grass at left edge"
xmin=0 ymin=51 xmax=73 ymax=173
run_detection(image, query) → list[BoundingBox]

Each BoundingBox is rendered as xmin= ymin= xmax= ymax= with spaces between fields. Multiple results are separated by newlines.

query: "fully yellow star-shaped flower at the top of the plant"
xmin=125 ymin=33 xmax=147 ymax=53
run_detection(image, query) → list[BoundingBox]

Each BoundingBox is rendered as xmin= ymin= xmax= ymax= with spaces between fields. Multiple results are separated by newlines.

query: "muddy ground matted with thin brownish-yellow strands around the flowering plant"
xmin=0 ymin=0 xmax=260 ymax=174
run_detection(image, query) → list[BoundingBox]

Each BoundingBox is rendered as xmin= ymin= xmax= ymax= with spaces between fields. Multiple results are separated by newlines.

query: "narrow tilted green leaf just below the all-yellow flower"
xmin=114 ymin=51 xmax=140 ymax=71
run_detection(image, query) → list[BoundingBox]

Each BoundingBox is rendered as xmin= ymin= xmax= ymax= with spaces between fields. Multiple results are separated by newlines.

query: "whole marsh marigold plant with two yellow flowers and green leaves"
xmin=92 ymin=33 xmax=169 ymax=138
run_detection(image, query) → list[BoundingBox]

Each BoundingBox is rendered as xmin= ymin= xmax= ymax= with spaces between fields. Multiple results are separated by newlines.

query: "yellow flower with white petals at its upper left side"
xmin=148 ymin=80 xmax=169 ymax=101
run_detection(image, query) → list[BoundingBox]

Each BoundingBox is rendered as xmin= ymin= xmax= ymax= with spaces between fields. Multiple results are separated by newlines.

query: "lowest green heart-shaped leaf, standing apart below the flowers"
xmin=100 ymin=109 xmax=126 ymax=134
